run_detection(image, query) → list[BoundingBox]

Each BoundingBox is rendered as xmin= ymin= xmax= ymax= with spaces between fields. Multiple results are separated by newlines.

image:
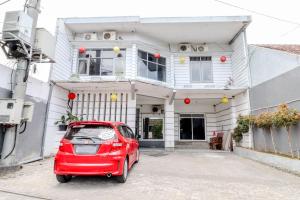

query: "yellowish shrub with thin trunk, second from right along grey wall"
xmin=254 ymin=112 xmax=277 ymax=153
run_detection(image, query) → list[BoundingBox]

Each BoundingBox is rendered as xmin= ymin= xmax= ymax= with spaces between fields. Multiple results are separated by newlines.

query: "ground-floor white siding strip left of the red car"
xmin=44 ymin=86 xmax=68 ymax=156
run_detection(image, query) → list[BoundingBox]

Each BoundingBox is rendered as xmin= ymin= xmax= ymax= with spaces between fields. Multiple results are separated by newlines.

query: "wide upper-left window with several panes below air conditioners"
xmin=78 ymin=49 xmax=125 ymax=76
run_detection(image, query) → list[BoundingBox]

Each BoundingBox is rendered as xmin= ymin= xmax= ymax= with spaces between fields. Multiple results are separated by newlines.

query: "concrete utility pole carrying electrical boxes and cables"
xmin=0 ymin=0 xmax=41 ymax=167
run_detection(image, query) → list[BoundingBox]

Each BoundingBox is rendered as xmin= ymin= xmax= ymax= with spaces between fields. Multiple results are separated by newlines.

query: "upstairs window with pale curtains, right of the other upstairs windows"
xmin=190 ymin=56 xmax=213 ymax=82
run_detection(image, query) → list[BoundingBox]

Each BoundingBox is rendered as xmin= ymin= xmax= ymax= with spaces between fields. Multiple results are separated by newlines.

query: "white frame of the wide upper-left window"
xmin=76 ymin=48 xmax=127 ymax=77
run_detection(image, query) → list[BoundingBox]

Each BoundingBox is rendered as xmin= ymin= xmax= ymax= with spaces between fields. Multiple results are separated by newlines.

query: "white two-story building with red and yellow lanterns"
xmin=45 ymin=16 xmax=251 ymax=155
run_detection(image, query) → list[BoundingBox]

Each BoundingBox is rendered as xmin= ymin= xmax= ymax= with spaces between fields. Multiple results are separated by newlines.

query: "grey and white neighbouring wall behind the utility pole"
xmin=0 ymin=63 xmax=49 ymax=163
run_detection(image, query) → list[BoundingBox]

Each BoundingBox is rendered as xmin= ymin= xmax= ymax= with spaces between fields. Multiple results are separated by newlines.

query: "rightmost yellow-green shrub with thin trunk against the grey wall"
xmin=272 ymin=104 xmax=300 ymax=158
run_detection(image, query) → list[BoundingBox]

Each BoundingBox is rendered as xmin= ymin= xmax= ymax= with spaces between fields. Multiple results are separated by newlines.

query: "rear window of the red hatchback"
xmin=65 ymin=125 xmax=115 ymax=140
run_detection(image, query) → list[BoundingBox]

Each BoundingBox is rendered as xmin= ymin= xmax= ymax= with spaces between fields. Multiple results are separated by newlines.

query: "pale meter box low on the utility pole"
xmin=0 ymin=99 xmax=24 ymax=124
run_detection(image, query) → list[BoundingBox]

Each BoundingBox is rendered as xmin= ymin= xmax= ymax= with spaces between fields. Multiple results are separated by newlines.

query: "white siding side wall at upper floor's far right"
xmin=231 ymin=32 xmax=249 ymax=87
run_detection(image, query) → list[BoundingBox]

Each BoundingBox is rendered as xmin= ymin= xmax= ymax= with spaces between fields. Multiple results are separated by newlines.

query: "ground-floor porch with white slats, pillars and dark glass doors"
xmin=52 ymin=80 xmax=248 ymax=150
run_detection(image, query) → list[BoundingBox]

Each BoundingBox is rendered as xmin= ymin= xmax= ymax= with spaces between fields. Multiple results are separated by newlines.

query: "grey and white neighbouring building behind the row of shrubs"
xmin=249 ymin=45 xmax=300 ymax=154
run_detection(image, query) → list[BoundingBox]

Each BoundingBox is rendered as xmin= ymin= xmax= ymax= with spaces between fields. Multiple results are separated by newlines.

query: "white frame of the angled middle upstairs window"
xmin=137 ymin=49 xmax=167 ymax=83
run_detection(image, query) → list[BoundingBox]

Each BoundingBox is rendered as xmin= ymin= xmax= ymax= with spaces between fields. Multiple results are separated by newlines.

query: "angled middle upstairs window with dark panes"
xmin=138 ymin=50 xmax=166 ymax=82
